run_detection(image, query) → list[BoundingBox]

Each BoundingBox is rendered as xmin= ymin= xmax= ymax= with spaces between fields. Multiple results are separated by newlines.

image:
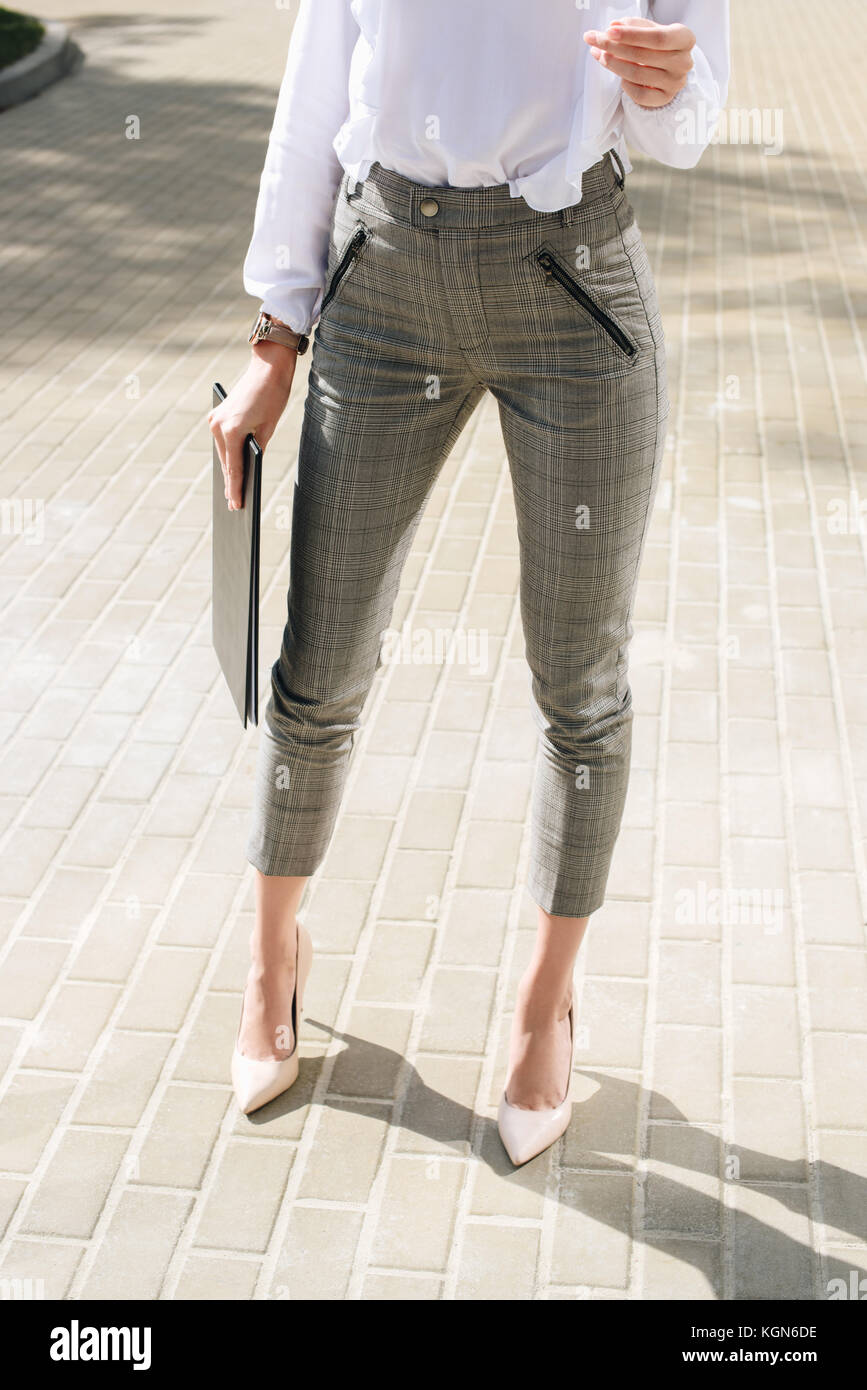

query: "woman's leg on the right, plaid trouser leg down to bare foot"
xmin=483 ymin=168 xmax=668 ymax=1109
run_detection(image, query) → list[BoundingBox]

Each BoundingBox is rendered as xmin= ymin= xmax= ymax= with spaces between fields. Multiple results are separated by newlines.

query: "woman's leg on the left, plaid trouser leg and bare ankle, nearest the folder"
xmin=240 ymin=179 xmax=482 ymax=1058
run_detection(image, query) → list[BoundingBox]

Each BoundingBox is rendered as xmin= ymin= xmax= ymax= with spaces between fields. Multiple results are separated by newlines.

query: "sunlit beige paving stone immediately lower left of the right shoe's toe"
xmin=372 ymin=1156 xmax=465 ymax=1270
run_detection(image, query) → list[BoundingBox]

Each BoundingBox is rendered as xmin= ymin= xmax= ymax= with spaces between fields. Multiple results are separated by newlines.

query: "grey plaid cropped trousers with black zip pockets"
xmin=247 ymin=157 xmax=668 ymax=917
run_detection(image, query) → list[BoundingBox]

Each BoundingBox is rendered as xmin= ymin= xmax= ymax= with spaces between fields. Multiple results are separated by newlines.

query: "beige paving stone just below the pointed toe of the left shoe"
xmin=196 ymin=1138 xmax=295 ymax=1254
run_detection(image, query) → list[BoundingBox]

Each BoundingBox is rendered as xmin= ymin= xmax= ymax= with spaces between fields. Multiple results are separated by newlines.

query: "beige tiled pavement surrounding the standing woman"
xmin=0 ymin=0 xmax=867 ymax=1300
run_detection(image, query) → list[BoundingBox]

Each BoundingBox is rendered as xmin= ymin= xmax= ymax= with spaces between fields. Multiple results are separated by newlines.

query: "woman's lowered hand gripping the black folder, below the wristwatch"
xmin=208 ymin=342 xmax=297 ymax=512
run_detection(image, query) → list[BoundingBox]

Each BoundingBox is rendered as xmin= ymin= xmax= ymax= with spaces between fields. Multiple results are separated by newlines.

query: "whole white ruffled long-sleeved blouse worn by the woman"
xmin=243 ymin=0 xmax=729 ymax=332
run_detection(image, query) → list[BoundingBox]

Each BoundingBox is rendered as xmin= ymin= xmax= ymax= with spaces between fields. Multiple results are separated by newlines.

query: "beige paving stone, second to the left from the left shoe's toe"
xmin=74 ymin=1029 xmax=172 ymax=1127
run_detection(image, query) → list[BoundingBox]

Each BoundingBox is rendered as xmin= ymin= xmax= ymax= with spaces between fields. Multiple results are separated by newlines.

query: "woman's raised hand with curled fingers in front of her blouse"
xmin=584 ymin=19 xmax=696 ymax=107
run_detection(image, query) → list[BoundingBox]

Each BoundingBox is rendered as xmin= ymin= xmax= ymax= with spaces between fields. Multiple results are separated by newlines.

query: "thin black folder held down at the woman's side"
xmin=211 ymin=382 xmax=263 ymax=728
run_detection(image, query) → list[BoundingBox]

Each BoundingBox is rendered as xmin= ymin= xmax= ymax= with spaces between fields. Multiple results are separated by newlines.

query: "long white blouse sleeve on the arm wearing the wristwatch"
xmin=243 ymin=0 xmax=358 ymax=334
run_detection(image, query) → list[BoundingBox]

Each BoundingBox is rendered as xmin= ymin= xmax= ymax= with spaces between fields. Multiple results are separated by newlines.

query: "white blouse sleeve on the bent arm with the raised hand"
xmin=622 ymin=0 xmax=731 ymax=170
